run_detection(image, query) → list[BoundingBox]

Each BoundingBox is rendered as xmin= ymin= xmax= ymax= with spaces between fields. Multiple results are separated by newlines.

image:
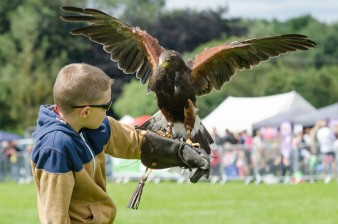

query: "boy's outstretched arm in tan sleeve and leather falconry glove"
xmin=106 ymin=118 xmax=210 ymax=183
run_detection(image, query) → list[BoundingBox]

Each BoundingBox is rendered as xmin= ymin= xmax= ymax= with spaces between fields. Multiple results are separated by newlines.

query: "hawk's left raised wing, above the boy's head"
xmin=61 ymin=7 xmax=164 ymax=84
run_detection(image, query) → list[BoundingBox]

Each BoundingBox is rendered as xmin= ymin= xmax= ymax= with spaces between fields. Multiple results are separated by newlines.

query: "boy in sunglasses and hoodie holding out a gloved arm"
xmin=32 ymin=64 xmax=209 ymax=224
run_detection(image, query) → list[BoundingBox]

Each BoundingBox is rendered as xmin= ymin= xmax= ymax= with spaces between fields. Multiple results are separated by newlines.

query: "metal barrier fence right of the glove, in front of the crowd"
xmin=210 ymin=142 xmax=338 ymax=184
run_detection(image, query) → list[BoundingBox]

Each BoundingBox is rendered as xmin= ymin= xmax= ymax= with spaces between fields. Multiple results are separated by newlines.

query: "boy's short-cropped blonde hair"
xmin=53 ymin=63 xmax=113 ymax=112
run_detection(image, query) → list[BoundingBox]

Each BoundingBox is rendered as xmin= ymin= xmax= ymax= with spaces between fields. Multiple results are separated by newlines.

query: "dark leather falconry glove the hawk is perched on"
xmin=141 ymin=131 xmax=210 ymax=183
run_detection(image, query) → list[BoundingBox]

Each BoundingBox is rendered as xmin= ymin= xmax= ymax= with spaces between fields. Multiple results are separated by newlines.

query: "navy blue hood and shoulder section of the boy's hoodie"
xmin=32 ymin=105 xmax=110 ymax=173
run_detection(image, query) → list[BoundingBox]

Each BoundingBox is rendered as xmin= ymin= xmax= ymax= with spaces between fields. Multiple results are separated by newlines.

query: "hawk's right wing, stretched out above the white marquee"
xmin=192 ymin=34 xmax=317 ymax=95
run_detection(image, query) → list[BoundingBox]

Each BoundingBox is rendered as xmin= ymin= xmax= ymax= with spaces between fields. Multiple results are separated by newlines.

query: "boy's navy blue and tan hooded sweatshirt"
xmin=32 ymin=106 xmax=144 ymax=224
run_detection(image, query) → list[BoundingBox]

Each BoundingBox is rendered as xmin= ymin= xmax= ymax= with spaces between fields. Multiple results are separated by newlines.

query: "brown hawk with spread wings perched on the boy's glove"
xmin=61 ymin=6 xmax=317 ymax=153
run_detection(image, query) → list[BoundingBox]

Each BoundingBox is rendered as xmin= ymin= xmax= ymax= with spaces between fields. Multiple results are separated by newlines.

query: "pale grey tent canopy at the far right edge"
xmin=293 ymin=103 xmax=338 ymax=126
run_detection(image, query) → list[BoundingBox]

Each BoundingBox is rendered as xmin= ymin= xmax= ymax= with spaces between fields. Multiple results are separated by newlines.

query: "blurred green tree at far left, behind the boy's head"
xmin=0 ymin=0 xmax=85 ymax=130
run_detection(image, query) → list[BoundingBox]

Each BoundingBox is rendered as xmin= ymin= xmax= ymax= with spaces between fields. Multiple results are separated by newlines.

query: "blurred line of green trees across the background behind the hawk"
xmin=0 ymin=0 xmax=338 ymax=132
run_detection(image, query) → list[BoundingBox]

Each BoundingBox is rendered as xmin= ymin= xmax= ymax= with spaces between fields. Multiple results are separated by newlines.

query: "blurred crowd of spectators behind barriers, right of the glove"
xmin=211 ymin=120 xmax=338 ymax=181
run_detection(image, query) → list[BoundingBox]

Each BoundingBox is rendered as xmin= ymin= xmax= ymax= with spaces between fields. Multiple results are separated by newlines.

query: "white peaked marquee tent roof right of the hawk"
xmin=202 ymin=91 xmax=316 ymax=132
